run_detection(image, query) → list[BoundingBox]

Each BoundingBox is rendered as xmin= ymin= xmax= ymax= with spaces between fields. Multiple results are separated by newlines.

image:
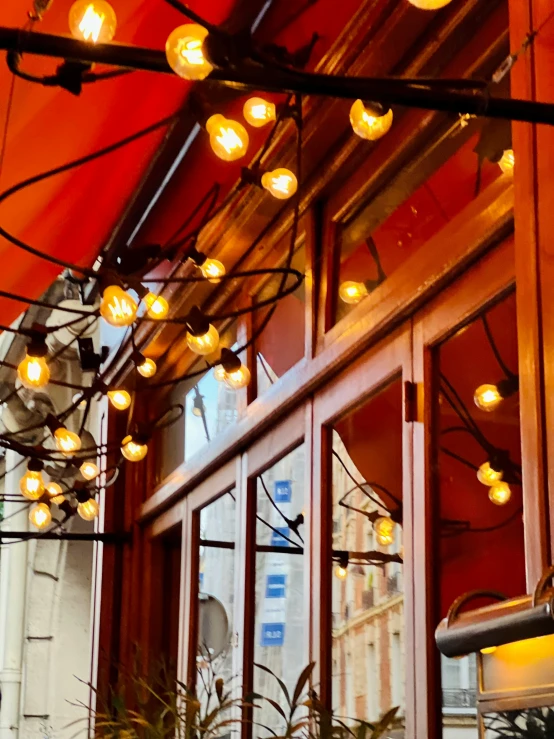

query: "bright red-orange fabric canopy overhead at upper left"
xmin=0 ymin=0 xmax=233 ymax=324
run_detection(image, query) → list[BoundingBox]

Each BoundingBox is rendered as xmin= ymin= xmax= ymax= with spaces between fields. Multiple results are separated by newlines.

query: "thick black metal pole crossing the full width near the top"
xmin=0 ymin=28 xmax=554 ymax=125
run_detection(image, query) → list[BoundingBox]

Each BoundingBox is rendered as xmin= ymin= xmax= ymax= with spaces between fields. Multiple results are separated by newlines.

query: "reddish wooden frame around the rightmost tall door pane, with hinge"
xmin=413 ymin=236 xmax=532 ymax=739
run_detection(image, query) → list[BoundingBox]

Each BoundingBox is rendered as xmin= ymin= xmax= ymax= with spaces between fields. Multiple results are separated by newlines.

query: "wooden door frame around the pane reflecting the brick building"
xmin=311 ymin=324 xmax=414 ymax=737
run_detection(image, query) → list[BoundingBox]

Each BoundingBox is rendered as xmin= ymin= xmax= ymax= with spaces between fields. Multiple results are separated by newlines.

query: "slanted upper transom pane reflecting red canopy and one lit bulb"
xmin=335 ymin=122 xmax=506 ymax=320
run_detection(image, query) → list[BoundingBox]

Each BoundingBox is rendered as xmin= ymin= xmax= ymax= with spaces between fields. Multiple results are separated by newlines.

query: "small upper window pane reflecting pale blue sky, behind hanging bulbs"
xmin=185 ymin=326 xmax=238 ymax=462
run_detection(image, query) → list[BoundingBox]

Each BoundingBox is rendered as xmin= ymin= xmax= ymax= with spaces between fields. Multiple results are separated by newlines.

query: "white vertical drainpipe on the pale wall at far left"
xmin=0 ymin=450 xmax=28 ymax=739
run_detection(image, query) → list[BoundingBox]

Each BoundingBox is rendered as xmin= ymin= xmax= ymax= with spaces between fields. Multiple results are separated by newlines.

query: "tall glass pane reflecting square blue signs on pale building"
xmin=254 ymin=445 xmax=308 ymax=735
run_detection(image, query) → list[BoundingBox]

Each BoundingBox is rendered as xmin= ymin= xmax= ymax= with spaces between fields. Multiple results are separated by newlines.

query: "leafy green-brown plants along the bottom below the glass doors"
xmin=78 ymin=663 xmax=398 ymax=739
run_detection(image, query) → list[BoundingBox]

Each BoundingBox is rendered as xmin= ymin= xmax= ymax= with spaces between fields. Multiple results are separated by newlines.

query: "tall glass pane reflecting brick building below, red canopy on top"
xmin=332 ymin=380 xmax=405 ymax=736
